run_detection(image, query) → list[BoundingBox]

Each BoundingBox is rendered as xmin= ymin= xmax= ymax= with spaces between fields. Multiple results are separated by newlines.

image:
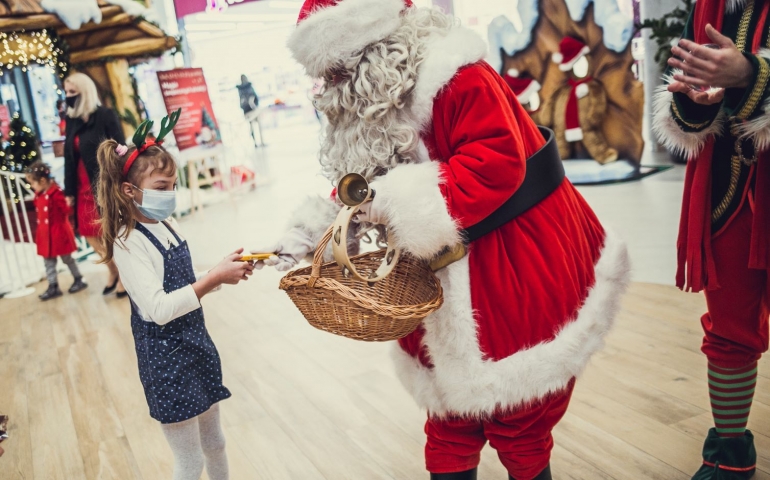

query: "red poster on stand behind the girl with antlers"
xmin=158 ymin=68 xmax=222 ymax=151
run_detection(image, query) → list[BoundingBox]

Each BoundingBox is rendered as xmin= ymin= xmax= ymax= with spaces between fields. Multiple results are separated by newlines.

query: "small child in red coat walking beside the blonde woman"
xmin=26 ymin=161 xmax=88 ymax=301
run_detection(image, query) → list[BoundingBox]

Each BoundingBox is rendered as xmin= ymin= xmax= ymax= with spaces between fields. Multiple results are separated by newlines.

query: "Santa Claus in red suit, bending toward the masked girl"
xmin=255 ymin=0 xmax=629 ymax=480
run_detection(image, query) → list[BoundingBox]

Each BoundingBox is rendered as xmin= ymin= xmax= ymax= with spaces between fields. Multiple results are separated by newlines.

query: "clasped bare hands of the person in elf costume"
xmin=668 ymin=24 xmax=754 ymax=88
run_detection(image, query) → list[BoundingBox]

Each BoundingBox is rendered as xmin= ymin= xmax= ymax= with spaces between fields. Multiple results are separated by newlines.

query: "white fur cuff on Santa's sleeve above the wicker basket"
xmin=372 ymin=162 xmax=461 ymax=259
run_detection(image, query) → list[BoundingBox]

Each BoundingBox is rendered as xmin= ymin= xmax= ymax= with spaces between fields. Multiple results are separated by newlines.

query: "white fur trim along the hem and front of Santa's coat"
xmin=393 ymin=232 xmax=630 ymax=417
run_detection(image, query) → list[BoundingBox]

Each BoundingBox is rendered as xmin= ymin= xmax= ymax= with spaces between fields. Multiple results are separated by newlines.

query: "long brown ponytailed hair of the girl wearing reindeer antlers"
xmin=96 ymin=140 xmax=176 ymax=263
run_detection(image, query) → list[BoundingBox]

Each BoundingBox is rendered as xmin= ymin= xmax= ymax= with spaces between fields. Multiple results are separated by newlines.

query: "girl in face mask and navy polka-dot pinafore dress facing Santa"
xmin=97 ymin=137 xmax=254 ymax=480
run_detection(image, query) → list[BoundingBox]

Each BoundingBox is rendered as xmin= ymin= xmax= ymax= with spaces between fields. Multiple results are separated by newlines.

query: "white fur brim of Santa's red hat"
xmin=287 ymin=0 xmax=405 ymax=78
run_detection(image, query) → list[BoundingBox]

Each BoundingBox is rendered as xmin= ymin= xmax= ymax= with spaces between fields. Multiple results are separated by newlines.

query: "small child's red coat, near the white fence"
xmin=35 ymin=183 xmax=77 ymax=258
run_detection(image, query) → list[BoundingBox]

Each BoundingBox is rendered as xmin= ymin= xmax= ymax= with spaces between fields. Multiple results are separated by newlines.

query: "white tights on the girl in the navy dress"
xmin=161 ymin=403 xmax=230 ymax=480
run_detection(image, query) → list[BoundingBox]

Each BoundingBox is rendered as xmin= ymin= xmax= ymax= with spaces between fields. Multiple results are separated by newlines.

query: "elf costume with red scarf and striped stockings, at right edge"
xmin=653 ymin=0 xmax=770 ymax=480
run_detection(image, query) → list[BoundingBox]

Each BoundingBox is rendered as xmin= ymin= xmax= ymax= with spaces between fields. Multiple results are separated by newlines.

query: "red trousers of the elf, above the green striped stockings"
xmin=701 ymin=194 xmax=770 ymax=368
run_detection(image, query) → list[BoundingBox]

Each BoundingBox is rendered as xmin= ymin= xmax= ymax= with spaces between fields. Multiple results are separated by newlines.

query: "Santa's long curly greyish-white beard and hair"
xmin=314 ymin=8 xmax=454 ymax=184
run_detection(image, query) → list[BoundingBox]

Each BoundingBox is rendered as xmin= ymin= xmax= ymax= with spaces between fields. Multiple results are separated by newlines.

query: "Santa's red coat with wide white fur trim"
xmin=290 ymin=0 xmax=629 ymax=417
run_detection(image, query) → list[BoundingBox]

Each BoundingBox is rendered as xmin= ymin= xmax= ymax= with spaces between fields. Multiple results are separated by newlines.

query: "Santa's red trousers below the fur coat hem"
xmin=425 ymin=379 xmax=575 ymax=480
